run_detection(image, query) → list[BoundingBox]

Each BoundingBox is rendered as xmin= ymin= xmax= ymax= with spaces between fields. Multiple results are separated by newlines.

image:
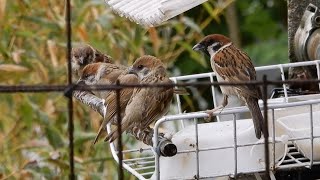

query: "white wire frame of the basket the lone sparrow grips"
xmin=107 ymin=60 xmax=320 ymax=179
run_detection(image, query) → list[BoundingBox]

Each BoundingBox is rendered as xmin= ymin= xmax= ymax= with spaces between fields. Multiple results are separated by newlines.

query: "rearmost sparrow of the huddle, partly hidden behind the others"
xmin=71 ymin=44 xmax=112 ymax=78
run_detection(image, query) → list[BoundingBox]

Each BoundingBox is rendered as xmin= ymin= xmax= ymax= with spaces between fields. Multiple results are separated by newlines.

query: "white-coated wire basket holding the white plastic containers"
xmin=108 ymin=60 xmax=320 ymax=179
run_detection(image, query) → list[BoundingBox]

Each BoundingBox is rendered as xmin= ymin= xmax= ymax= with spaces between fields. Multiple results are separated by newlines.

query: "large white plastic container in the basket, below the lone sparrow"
xmin=154 ymin=119 xmax=286 ymax=179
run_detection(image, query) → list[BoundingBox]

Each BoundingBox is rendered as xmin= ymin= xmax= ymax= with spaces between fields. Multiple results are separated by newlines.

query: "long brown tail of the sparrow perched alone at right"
xmin=246 ymin=97 xmax=264 ymax=139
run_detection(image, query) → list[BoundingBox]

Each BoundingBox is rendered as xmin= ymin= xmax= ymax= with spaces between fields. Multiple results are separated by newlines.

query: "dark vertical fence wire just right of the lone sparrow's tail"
xmin=262 ymin=75 xmax=270 ymax=178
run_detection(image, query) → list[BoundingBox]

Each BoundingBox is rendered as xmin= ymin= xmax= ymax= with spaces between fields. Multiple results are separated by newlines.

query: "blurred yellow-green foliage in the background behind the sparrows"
xmin=0 ymin=0 xmax=288 ymax=179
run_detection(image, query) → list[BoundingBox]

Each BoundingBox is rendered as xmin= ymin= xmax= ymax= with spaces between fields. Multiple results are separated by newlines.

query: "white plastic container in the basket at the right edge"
xmin=277 ymin=111 xmax=320 ymax=161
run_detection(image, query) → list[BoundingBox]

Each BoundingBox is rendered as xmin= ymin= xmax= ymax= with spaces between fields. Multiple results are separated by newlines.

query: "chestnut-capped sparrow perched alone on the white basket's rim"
xmin=193 ymin=34 xmax=263 ymax=139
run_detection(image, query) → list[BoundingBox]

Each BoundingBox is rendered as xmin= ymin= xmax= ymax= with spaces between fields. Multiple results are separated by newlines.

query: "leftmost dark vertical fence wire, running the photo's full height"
xmin=66 ymin=0 xmax=75 ymax=180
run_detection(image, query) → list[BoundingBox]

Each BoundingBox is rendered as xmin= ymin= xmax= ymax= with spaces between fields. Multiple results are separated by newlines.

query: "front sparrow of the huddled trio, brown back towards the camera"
xmin=105 ymin=56 xmax=174 ymax=142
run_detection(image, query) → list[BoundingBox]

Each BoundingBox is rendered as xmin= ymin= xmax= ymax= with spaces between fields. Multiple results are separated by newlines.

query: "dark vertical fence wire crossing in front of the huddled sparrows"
xmin=116 ymin=80 xmax=124 ymax=180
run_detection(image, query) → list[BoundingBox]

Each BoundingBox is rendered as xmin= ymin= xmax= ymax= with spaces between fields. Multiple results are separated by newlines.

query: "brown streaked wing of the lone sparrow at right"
xmin=214 ymin=45 xmax=260 ymax=98
